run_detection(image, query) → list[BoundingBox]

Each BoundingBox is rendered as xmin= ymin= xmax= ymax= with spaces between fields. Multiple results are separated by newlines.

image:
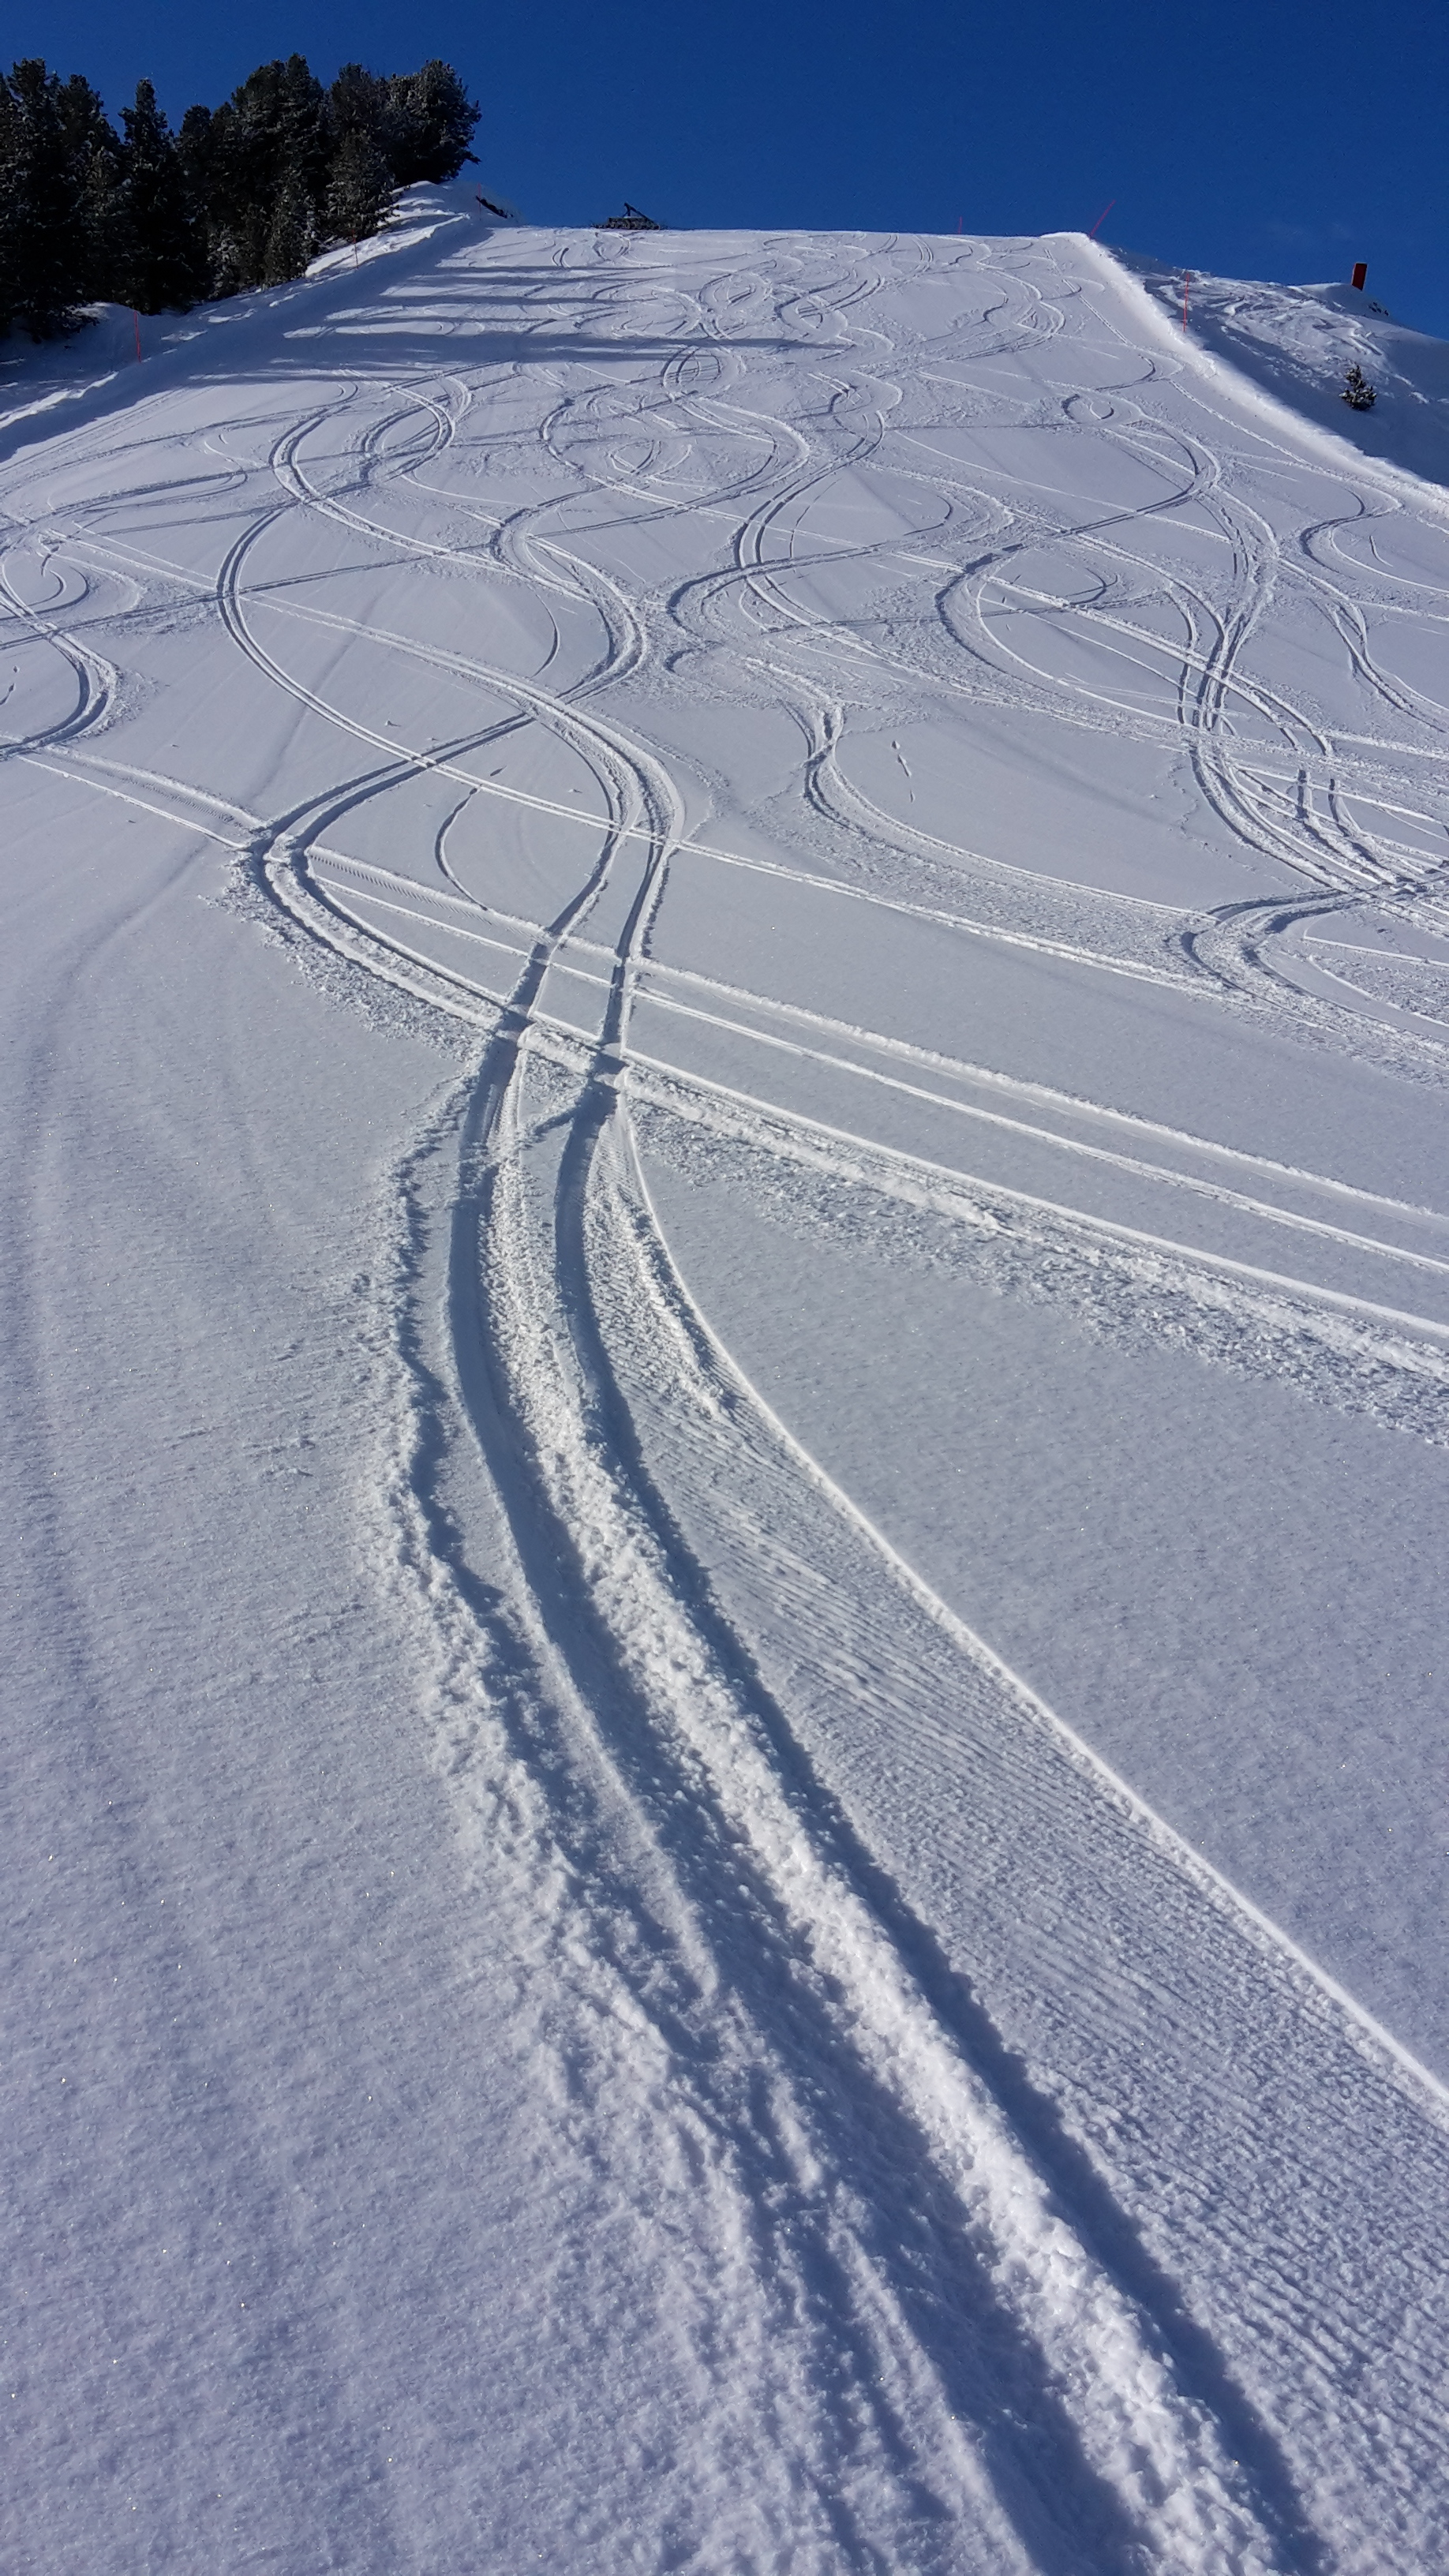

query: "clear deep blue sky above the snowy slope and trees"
xmin=11 ymin=0 xmax=1449 ymax=338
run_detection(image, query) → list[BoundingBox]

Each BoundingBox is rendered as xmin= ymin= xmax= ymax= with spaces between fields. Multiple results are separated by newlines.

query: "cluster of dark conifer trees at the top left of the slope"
xmin=0 ymin=54 xmax=480 ymax=340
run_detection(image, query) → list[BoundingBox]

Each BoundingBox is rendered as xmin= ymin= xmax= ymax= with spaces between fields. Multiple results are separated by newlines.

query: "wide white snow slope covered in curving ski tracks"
xmin=0 ymin=188 xmax=1449 ymax=2576
